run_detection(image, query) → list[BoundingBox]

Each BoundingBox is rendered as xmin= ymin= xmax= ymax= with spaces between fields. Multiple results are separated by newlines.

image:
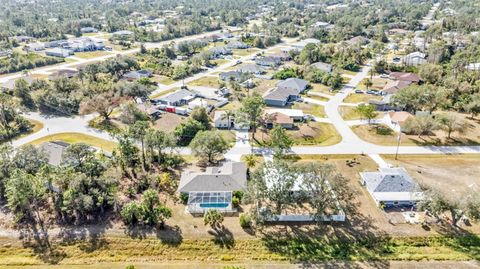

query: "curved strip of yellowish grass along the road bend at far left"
xmin=30 ymin=133 xmax=117 ymax=152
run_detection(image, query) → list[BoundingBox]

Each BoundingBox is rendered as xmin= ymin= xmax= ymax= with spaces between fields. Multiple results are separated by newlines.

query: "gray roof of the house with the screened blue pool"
xmin=178 ymin=162 xmax=247 ymax=192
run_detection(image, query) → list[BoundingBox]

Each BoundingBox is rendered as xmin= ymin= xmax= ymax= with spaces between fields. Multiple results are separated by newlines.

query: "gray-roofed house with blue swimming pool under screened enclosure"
xmin=177 ymin=162 xmax=247 ymax=214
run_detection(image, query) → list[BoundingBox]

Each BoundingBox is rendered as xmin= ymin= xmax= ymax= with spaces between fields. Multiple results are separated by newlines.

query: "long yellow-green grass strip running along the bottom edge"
xmin=0 ymin=233 xmax=480 ymax=268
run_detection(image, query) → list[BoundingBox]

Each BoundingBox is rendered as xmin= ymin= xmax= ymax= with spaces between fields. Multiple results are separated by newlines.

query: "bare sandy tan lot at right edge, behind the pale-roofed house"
xmin=383 ymin=154 xmax=480 ymax=198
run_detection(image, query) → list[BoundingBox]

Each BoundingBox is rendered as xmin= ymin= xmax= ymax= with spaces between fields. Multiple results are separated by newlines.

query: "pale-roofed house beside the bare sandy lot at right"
xmin=360 ymin=168 xmax=423 ymax=208
